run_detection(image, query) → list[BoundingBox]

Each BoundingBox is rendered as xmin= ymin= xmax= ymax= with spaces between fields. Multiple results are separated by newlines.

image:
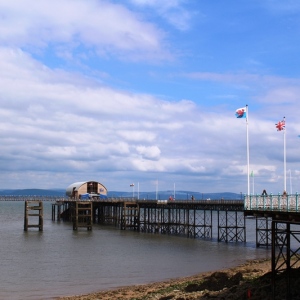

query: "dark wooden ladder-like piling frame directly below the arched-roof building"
xmin=73 ymin=201 xmax=93 ymax=230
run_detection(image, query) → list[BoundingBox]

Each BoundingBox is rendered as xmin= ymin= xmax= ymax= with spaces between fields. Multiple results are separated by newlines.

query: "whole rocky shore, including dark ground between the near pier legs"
xmin=59 ymin=260 xmax=300 ymax=300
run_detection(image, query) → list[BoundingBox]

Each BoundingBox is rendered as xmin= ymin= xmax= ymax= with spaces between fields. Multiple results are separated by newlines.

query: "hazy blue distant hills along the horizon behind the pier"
xmin=0 ymin=189 xmax=241 ymax=200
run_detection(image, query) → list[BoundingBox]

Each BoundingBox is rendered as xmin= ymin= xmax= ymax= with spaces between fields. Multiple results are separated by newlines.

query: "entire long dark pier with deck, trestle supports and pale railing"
xmin=0 ymin=194 xmax=300 ymax=247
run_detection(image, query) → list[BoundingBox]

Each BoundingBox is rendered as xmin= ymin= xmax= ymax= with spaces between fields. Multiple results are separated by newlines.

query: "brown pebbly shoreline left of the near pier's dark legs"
xmin=56 ymin=258 xmax=271 ymax=300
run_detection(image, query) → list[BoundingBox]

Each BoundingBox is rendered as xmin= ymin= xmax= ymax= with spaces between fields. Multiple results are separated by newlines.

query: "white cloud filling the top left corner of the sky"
xmin=0 ymin=0 xmax=169 ymax=59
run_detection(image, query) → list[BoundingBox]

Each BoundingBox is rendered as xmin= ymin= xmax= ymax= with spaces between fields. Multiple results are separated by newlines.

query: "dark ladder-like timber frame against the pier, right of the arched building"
xmin=121 ymin=202 xmax=140 ymax=230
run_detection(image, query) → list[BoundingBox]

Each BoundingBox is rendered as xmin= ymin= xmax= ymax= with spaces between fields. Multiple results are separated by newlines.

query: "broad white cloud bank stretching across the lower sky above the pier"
xmin=0 ymin=49 xmax=300 ymax=190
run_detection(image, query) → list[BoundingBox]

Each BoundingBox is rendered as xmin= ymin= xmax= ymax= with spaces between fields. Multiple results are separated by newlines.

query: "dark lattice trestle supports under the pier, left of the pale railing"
xmin=52 ymin=198 xmax=246 ymax=242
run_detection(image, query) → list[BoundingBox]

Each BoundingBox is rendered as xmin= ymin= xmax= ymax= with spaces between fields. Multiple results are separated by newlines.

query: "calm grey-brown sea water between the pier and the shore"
xmin=0 ymin=201 xmax=271 ymax=300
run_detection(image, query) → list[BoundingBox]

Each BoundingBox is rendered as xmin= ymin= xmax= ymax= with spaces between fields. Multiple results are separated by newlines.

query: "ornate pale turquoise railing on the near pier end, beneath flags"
xmin=244 ymin=193 xmax=300 ymax=212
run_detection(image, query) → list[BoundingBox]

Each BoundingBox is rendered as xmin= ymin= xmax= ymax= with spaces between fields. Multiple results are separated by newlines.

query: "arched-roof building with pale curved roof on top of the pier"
xmin=66 ymin=181 xmax=107 ymax=200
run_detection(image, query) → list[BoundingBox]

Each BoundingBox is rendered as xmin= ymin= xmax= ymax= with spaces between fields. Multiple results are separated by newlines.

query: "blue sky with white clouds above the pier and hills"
xmin=0 ymin=0 xmax=300 ymax=194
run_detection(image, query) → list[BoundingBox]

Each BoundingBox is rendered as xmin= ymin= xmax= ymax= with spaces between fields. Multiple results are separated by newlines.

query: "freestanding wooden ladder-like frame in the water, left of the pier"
xmin=24 ymin=200 xmax=44 ymax=231
